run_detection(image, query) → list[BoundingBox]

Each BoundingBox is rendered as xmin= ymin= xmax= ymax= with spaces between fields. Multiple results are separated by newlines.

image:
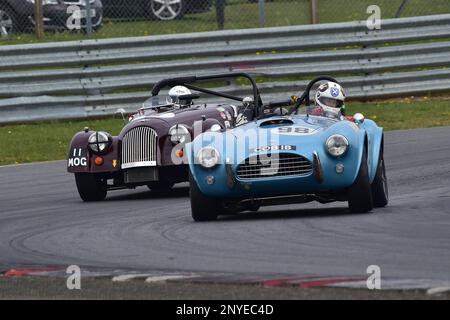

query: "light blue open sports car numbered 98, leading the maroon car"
xmin=185 ymin=77 xmax=388 ymax=221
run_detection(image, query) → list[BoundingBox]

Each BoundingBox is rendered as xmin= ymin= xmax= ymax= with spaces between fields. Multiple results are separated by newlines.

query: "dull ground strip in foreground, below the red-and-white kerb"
xmin=0 ymin=276 xmax=450 ymax=305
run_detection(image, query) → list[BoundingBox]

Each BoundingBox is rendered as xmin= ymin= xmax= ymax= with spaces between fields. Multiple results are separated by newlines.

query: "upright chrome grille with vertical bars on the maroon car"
xmin=122 ymin=127 xmax=158 ymax=169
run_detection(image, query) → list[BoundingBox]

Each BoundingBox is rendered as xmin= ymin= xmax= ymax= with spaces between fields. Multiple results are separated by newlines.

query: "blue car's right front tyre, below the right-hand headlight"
xmin=348 ymin=149 xmax=373 ymax=213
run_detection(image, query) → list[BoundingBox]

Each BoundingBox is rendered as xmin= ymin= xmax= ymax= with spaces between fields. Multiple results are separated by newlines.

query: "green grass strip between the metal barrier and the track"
xmin=0 ymin=98 xmax=450 ymax=165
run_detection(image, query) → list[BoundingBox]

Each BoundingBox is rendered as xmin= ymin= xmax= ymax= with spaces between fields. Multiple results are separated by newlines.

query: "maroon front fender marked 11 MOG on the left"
xmin=67 ymin=131 xmax=120 ymax=173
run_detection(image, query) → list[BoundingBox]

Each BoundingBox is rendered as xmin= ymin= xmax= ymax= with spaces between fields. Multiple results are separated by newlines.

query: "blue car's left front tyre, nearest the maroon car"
xmin=189 ymin=173 xmax=221 ymax=221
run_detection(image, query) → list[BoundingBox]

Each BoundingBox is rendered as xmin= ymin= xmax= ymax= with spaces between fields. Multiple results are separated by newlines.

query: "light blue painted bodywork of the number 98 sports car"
xmin=185 ymin=115 xmax=383 ymax=199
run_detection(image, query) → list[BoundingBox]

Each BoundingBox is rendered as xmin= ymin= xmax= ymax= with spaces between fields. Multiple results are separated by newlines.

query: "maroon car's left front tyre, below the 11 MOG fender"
xmin=75 ymin=173 xmax=108 ymax=202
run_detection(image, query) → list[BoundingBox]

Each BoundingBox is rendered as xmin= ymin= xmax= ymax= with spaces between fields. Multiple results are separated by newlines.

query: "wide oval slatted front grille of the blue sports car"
xmin=237 ymin=153 xmax=313 ymax=179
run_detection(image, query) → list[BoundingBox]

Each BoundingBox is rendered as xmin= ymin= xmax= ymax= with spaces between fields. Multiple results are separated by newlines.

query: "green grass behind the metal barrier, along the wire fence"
xmin=0 ymin=0 xmax=450 ymax=45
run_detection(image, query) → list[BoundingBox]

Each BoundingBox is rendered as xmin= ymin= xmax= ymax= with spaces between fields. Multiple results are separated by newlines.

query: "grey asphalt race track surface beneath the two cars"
xmin=0 ymin=127 xmax=450 ymax=281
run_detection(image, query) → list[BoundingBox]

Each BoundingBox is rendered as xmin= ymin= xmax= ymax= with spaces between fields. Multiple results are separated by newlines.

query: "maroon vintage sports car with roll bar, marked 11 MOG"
xmin=67 ymin=73 xmax=261 ymax=201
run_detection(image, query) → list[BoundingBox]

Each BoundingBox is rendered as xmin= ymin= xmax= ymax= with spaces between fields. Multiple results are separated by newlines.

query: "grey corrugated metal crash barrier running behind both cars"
xmin=0 ymin=14 xmax=450 ymax=123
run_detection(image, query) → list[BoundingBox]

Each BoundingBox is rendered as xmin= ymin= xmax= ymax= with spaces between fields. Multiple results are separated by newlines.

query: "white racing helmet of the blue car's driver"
xmin=316 ymin=82 xmax=345 ymax=118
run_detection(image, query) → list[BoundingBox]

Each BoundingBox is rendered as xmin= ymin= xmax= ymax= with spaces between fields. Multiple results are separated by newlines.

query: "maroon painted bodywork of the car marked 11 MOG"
xmin=67 ymin=104 xmax=239 ymax=188
